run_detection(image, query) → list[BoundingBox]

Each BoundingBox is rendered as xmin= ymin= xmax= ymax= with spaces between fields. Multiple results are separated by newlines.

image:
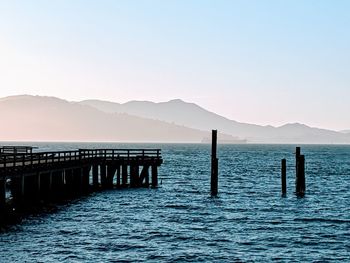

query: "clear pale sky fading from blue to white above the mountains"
xmin=0 ymin=0 xmax=350 ymax=130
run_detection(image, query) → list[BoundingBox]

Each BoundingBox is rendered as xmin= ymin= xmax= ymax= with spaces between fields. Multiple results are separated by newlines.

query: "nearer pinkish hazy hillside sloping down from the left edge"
xmin=0 ymin=95 xmax=239 ymax=142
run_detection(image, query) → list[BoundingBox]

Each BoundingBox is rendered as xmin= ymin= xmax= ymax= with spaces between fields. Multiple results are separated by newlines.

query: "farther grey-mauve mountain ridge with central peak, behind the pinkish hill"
xmin=79 ymin=99 xmax=350 ymax=144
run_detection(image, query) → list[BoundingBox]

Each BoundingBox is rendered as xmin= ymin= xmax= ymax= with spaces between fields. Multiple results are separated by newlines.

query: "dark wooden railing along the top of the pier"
xmin=0 ymin=149 xmax=162 ymax=173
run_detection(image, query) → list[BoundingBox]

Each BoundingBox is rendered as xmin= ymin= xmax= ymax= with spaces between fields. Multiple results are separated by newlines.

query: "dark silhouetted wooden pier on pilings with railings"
xmin=0 ymin=147 xmax=163 ymax=220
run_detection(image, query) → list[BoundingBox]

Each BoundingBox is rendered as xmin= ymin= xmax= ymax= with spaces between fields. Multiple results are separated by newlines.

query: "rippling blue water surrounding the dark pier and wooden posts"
xmin=0 ymin=144 xmax=350 ymax=262
